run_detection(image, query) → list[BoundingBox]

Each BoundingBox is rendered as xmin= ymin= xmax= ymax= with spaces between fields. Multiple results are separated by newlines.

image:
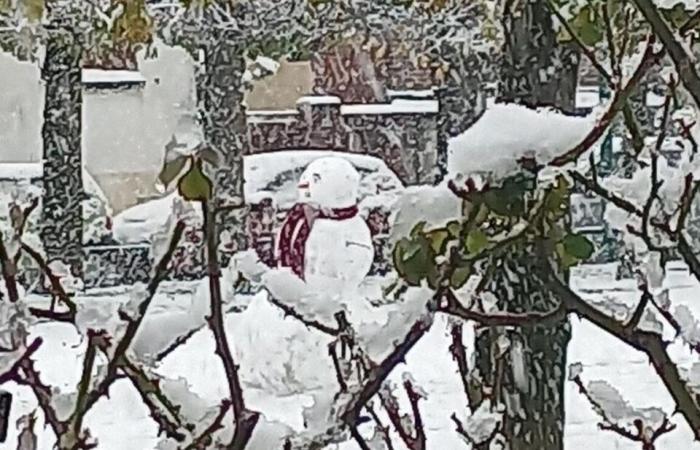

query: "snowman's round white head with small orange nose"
xmin=299 ymin=156 xmax=360 ymax=208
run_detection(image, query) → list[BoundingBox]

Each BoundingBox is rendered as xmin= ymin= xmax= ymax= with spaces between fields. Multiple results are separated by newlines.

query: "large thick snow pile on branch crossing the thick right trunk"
xmin=447 ymin=103 xmax=597 ymax=178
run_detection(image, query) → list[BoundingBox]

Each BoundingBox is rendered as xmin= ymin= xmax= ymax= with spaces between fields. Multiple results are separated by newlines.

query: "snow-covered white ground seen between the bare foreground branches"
xmin=0 ymin=266 xmax=700 ymax=450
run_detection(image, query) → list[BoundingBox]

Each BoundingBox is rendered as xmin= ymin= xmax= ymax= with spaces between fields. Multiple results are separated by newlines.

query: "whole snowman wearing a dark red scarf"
xmin=223 ymin=157 xmax=374 ymax=396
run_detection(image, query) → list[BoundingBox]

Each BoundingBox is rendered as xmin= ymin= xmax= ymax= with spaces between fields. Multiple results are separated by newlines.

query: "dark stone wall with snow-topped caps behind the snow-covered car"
xmin=248 ymin=91 xmax=439 ymax=185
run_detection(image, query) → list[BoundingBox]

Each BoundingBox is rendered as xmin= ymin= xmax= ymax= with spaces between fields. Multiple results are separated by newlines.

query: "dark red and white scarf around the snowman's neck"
xmin=276 ymin=203 xmax=359 ymax=280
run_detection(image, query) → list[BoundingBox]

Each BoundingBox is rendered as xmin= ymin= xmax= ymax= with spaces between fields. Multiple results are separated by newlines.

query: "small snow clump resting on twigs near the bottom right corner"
xmin=587 ymin=380 xmax=666 ymax=429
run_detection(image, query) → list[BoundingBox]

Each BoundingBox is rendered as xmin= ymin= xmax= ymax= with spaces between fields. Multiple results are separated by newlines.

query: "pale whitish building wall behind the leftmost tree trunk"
xmin=0 ymin=40 xmax=194 ymax=209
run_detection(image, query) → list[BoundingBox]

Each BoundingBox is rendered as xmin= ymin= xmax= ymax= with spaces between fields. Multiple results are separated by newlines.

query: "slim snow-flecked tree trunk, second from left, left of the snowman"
xmin=197 ymin=31 xmax=247 ymax=265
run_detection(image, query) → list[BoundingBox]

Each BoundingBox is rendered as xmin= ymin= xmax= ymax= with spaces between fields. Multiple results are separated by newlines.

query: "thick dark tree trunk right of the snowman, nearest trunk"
xmin=477 ymin=0 xmax=579 ymax=450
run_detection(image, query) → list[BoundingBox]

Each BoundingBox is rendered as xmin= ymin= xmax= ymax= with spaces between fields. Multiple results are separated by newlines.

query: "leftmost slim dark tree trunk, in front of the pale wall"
xmin=40 ymin=15 xmax=84 ymax=276
